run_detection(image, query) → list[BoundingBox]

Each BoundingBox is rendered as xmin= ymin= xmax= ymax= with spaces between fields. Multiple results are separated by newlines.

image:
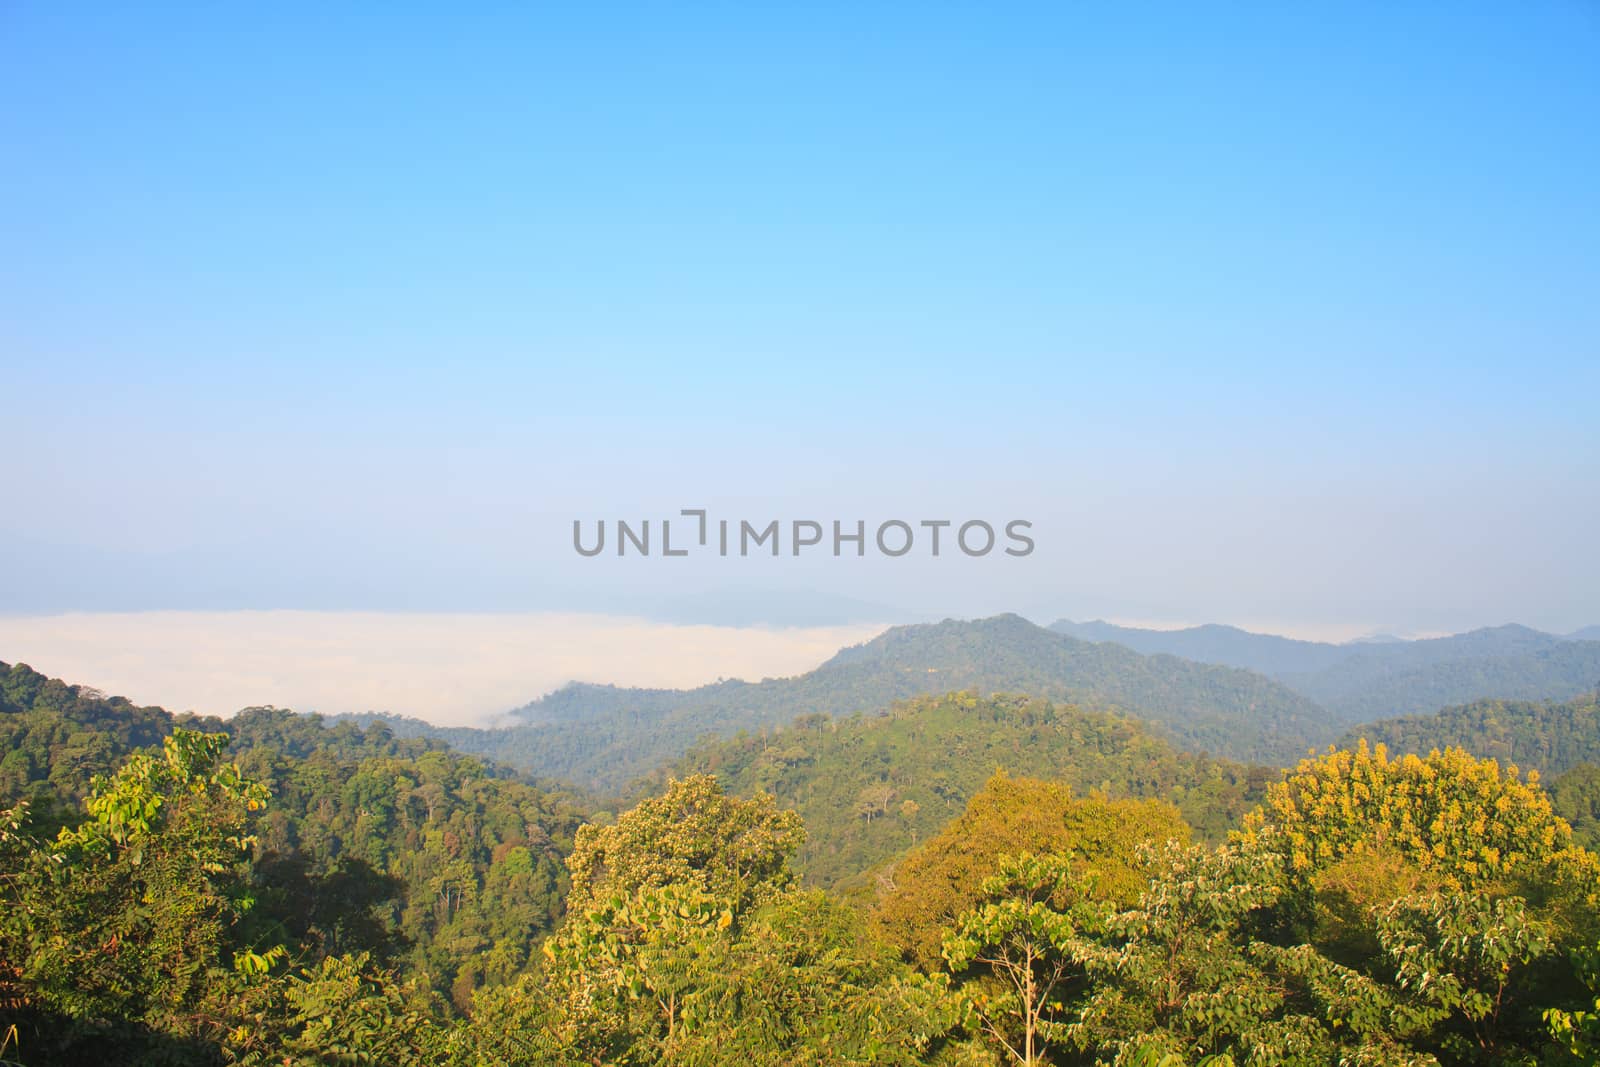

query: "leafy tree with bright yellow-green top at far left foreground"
xmin=0 ymin=729 xmax=267 ymax=1049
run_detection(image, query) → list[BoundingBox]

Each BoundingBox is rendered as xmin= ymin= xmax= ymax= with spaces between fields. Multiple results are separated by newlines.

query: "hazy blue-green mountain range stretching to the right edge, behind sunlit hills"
xmin=363 ymin=614 xmax=1600 ymax=792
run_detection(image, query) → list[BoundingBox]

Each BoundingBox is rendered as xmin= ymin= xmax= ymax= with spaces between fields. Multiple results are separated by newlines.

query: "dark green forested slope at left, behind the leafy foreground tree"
xmin=0 ymin=664 xmax=586 ymax=1043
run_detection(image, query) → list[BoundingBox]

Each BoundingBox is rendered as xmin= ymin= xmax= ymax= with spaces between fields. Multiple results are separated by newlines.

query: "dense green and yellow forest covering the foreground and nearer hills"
xmin=0 ymin=667 xmax=1600 ymax=1067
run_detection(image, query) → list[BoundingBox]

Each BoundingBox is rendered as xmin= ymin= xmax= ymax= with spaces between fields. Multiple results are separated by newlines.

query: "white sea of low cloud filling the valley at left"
xmin=0 ymin=611 xmax=883 ymax=725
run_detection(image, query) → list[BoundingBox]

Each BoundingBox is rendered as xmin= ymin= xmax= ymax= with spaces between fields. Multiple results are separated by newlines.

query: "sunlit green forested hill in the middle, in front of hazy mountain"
xmin=674 ymin=691 xmax=1278 ymax=888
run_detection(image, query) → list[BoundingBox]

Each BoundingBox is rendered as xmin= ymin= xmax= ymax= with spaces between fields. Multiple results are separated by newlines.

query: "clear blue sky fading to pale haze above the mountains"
xmin=0 ymin=0 xmax=1600 ymax=630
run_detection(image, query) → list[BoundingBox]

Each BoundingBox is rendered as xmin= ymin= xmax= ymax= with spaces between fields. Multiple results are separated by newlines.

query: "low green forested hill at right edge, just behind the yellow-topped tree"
xmin=1339 ymin=693 xmax=1600 ymax=777
